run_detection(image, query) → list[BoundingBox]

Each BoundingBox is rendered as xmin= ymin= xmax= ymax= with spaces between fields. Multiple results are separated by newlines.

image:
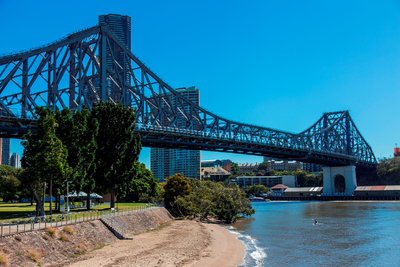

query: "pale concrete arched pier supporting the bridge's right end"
xmin=323 ymin=166 xmax=357 ymax=194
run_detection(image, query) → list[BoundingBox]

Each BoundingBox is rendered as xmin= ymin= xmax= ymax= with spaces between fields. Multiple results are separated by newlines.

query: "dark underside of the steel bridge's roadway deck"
xmin=0 ymin=120 xmax=376 ymax=171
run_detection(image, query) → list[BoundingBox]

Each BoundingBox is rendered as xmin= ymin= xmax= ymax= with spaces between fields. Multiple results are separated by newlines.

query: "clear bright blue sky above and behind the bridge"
xmin=0 ymin=0 xmax=400 ymax=167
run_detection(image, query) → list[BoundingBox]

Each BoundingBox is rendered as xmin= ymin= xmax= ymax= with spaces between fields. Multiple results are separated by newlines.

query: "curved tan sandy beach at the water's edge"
xmin=69 ymin=220 xmax=245 ymax=267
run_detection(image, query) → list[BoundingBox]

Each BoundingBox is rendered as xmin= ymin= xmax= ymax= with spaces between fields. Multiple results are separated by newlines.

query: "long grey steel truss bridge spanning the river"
xmin=0 ymin=24 xmax=376 ymax=168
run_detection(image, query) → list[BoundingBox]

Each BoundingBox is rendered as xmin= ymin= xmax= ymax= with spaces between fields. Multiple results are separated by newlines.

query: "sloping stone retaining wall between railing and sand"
xmin=0 ymin=208 xmax=173 ymax=266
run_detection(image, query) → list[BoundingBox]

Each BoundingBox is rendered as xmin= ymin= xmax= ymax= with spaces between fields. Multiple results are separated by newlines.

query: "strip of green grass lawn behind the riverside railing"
xmin=0 ymin=202 xmax=150 ymax=221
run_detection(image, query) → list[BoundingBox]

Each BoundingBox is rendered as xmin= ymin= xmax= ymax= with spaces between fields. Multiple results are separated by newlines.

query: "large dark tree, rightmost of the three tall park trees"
xmin=92 ymin=101 xmax=142 ymax=208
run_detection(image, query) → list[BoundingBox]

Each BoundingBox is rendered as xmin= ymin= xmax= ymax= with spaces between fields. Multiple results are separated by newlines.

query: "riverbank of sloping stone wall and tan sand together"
xmin=0 ymin=208 xmax=246 ymax=267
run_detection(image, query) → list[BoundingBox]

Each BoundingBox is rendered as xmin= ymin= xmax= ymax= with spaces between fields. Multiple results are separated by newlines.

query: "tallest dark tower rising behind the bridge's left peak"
xmin=99 ymin=14 xmax=131 ymax=84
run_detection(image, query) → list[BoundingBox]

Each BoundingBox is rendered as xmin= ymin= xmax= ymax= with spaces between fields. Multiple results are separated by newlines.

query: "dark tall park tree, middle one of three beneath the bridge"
xmin=55 ymin=106 xmax=99 ymax=209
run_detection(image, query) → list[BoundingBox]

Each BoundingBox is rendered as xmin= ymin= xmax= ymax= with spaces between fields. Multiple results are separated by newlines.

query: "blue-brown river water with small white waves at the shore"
xmin=227 ymin=201 xmax=400 ymax=266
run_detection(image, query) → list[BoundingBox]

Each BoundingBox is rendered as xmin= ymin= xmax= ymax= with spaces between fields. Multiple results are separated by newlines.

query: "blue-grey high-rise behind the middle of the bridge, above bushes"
xmin=150 ymin=86 xmax=201 ymax=182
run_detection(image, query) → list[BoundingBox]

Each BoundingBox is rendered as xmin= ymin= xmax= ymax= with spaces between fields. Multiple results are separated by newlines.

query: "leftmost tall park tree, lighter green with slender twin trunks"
xmin=22 ymin=107 xmax=72 ymax=215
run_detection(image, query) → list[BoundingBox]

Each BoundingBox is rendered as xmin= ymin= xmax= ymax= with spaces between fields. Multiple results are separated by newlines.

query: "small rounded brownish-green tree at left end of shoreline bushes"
xmin=163 ymin=173 xmax=192 ymax=211
